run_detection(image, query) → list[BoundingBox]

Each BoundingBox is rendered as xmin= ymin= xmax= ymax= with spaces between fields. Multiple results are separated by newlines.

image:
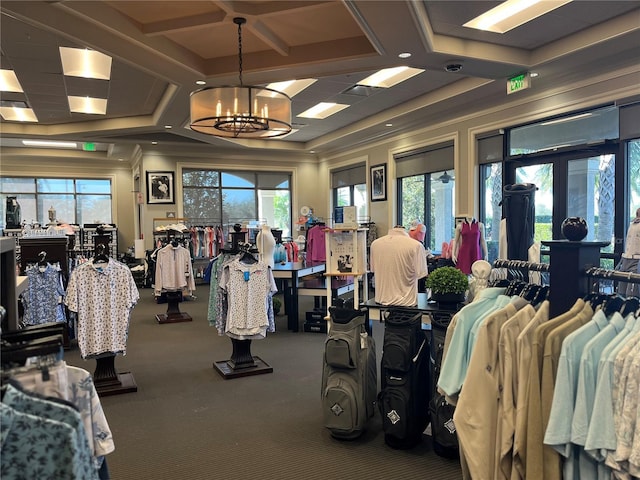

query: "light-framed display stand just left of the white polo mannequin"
xmin=324 ymin=228 xmax=369 ymax=312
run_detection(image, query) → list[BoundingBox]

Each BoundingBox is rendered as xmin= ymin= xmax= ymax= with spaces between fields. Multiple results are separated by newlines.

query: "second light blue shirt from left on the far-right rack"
xmin=571 ymin=312 xmax=625 ymax=480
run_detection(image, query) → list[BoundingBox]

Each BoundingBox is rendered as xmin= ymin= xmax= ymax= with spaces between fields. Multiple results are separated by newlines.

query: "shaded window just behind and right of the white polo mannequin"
xmin=394 ymin=142 xmax=455 ymax=251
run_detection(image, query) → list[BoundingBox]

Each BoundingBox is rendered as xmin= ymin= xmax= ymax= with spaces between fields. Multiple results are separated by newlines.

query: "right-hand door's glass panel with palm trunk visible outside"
xmin=567 ymin=154 xmax=616 ymax=252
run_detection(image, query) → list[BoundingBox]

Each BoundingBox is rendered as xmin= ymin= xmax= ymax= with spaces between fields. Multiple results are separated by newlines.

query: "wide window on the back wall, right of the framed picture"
xmin=182 ymin=169 xmax=291 ymax=237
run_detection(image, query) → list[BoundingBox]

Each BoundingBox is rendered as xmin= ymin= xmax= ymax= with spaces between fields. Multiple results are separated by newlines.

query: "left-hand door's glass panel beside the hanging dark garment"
xmin=516 ymin=163 xmax=553 ymax=242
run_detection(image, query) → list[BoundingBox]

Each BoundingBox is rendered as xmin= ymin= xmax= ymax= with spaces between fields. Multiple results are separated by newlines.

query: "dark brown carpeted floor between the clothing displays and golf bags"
xmin=65 ymin=286 xmax=462 ymax=480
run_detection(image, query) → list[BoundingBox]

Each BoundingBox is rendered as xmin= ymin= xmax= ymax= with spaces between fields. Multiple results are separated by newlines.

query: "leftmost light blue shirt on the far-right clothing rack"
xmin=544 ymin=310 xmax=609 ymax=480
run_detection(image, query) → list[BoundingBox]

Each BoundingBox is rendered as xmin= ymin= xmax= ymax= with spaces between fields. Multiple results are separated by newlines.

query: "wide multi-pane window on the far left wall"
xmin=0 ymin=177 xmax=112 ymax=225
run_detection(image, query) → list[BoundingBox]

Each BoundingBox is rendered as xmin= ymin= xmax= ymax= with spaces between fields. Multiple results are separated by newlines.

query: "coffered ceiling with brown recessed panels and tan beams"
xmin=0 ymin=0 xmax=640 ymax=155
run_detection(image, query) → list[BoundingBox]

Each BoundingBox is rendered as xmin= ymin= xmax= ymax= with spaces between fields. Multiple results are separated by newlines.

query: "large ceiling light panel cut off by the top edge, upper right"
xmin=463 ymin=0 xmax=571 ymax=33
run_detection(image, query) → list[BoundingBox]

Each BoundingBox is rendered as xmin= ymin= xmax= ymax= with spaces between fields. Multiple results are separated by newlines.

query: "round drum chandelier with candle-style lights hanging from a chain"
xmin=190 ymin=17 xmax=291 ymax=138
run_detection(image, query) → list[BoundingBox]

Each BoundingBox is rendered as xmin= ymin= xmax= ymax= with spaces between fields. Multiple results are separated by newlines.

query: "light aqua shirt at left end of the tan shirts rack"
xmin=438 ymin=287 xmax=508 ymax=396
